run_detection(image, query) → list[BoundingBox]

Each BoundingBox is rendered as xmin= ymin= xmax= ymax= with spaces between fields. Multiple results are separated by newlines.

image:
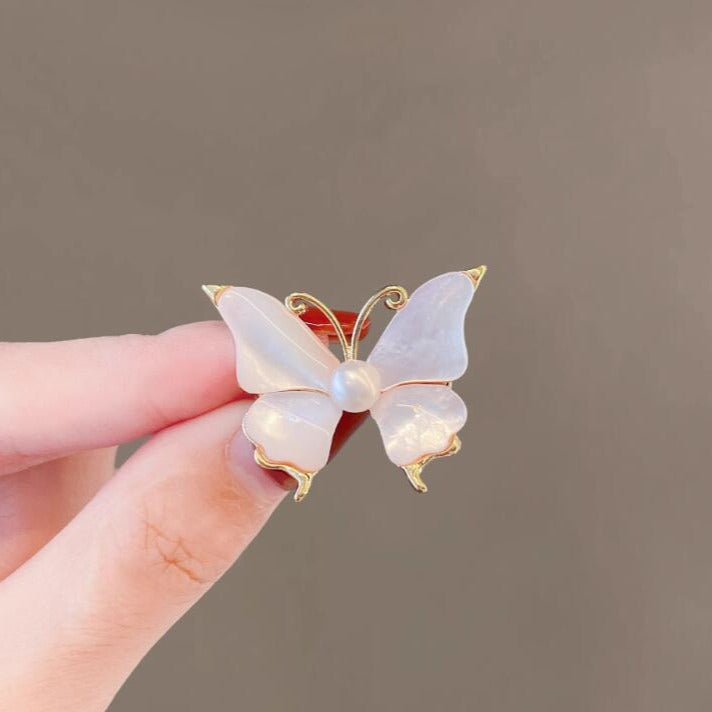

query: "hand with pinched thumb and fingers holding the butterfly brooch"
xmin=0 ymin=322 xmax=364 ymax=712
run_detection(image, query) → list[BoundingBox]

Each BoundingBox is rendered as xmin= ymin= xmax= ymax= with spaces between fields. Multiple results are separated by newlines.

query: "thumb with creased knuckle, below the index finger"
xmin=0 ymin=402 xmax=285 ymax=712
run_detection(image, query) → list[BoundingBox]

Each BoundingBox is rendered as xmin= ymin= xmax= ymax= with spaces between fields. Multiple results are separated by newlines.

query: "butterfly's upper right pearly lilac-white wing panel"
xmin=367 ymin=272 xmax=475 ymax=388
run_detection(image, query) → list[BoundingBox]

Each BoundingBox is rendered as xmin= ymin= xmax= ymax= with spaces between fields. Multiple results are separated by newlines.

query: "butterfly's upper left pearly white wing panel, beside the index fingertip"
xmin=217 ymin=287 xmax=339 ymax=393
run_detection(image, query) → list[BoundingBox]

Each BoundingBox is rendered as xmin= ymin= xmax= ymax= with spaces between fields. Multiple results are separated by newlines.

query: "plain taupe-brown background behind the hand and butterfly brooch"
xmin=0 ymin=0 xmax=712 ymax=712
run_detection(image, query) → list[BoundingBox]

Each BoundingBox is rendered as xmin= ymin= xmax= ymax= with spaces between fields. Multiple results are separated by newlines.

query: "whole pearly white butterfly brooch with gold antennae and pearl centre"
xmin=203 ymin=265 xmax=487 ymax=502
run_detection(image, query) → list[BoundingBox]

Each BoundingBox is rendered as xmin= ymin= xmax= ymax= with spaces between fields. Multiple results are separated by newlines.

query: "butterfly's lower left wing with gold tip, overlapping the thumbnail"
xmin=242 ymin=391 xmax=341 ymax=501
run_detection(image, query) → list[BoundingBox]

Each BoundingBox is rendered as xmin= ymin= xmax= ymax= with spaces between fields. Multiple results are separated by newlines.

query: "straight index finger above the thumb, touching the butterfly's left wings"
xmin=0 ymin=322 xmax=241 ymax=474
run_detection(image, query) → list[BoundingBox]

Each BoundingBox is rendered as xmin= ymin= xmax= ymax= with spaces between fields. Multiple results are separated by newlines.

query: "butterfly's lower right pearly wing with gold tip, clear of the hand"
xmin=371 ymin=383 xmax=467 ymax=492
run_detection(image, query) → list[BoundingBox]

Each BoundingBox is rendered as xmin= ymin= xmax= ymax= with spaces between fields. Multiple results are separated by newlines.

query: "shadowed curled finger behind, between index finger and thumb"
xmin=0 ymin=447 xmax=116 ymax=581
